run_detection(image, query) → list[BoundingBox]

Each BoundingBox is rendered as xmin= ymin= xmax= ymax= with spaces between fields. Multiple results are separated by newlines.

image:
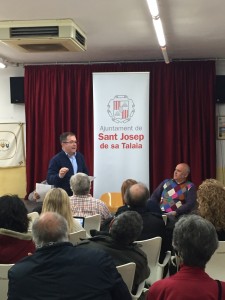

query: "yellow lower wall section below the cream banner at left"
xmin=0 ymin=167 xmax=26 ymax=198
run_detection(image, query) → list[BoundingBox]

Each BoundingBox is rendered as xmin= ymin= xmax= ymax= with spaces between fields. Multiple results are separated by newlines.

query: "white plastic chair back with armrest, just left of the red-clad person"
xmin=137 ymin=236 xmax=171 ymax=285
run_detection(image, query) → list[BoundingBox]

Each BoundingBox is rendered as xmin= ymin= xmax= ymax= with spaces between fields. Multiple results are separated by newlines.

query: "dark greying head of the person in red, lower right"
xmin=173 ymin=215 xmax=218 ymax=268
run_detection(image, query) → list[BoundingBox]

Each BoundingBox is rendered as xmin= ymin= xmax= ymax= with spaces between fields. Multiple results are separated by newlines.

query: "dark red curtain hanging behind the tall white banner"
xmin=25 ymin=61 xmax=216 ymax=197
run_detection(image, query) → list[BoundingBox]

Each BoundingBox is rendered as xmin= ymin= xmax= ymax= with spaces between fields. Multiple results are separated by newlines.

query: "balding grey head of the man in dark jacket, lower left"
xmin=32 ymin=212 xmax=68 ymax=248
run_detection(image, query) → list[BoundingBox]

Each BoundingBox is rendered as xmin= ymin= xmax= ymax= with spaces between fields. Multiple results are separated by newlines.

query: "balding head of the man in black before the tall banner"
xmin=125 ymin=183 xmax=150 ymax=208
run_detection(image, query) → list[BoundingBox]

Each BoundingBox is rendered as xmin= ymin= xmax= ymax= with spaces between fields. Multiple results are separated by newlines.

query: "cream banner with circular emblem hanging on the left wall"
xmin=0 ymin=123 xmax=25 ymax=168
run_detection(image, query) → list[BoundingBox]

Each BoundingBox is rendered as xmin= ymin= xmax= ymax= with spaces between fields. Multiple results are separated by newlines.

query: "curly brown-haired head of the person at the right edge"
xmin=197 ymin=179 xmax=225 ymax=241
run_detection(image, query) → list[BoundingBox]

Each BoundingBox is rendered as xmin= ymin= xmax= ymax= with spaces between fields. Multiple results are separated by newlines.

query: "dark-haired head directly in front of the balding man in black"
xmin=110 ymin=211 xmax=143 ymax=245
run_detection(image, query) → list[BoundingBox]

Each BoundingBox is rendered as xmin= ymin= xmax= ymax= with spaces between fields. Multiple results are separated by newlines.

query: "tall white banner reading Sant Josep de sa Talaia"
xmin=93 ymin=72 xmax=149 ymax=198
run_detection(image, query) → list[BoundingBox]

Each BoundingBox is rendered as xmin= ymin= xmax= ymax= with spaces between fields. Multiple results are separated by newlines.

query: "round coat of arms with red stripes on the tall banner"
xmin=107 ymin=95 xmax=135 ymax=123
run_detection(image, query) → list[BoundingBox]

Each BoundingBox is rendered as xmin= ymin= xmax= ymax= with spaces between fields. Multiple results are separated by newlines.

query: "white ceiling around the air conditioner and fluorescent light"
xmin=0 ymin=0 xmax=225 ymax=64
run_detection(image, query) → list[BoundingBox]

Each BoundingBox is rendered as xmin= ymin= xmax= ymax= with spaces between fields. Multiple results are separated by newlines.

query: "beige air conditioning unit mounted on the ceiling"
xmin=0 ymin=19 xmax=87 ymax=53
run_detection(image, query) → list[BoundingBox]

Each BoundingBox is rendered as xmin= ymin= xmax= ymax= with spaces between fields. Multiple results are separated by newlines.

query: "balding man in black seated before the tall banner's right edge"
xmin=116 ymin=183 xmax=171 ymax=262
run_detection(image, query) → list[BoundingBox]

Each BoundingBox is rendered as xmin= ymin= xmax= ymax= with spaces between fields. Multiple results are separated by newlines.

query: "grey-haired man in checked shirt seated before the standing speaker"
xmin=70 ymin=173 xmax=111 ymax=223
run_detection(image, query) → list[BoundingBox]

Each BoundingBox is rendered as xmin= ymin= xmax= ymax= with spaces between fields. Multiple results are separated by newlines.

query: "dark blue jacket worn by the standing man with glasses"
xmin=47 ymin=151 xmax=88 ymax=196
